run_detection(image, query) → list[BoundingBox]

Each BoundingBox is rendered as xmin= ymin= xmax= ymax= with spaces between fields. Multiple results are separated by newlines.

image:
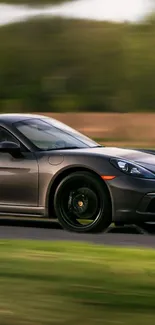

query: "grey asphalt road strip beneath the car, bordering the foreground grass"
xmin=0 ymin=218 xmax=155 ymax=248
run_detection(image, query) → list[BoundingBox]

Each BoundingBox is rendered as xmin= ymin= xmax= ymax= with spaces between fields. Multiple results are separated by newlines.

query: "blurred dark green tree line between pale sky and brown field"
xmin=0 ymin=16 xmax=155 ymax=112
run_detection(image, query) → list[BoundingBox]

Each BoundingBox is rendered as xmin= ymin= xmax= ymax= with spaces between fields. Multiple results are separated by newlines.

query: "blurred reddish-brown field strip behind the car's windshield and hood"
xmin=40 ymin=113 xmax=155 ymax=148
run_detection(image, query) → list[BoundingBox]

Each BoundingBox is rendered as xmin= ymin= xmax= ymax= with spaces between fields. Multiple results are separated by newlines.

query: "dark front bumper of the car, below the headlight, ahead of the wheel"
xmin=107 ymin=176 xmax=155 ymax=223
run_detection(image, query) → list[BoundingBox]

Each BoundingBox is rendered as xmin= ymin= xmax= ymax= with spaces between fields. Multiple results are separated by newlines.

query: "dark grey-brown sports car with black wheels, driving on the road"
xmin=0 ymin=114 xmax=155 ymax=232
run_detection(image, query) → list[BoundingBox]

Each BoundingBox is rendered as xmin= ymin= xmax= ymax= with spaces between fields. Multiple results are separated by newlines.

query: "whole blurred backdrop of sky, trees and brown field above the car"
xmin=0 ymin=0 xmax=155 ymax=147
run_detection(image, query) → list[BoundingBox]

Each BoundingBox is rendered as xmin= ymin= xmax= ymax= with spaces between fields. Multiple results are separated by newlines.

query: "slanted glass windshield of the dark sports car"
xmin=15 ymin=118 xmax=98 ymax=151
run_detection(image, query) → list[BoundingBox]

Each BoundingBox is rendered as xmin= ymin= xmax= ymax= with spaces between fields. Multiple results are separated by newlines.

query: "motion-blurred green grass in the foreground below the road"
xmin=0 ymin=240 xmax=155 ymax=325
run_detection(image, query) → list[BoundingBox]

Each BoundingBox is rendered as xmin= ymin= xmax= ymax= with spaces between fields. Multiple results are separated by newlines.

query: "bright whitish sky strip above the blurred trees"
xmin=0 ymin=0 xmax=152 ymax=25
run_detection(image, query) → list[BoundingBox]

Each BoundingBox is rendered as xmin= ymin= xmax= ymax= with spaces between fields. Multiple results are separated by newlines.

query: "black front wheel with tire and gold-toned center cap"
xmin=54 ymin=171 xmax=111 ymax=233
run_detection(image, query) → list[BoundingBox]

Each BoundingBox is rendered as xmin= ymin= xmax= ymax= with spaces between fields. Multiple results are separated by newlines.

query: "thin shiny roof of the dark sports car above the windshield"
xmin=0 ymin=113 xmax=46 ymax=124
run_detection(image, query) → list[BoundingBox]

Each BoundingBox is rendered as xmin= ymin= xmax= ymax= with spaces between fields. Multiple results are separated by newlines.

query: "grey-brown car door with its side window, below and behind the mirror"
xmin=0 ymin=127 xmax=38 ymax=206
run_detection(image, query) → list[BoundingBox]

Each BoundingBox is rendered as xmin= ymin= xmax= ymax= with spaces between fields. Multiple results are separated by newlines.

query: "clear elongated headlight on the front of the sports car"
xmin=110 ymin=159 xmax=155 ymax=178
